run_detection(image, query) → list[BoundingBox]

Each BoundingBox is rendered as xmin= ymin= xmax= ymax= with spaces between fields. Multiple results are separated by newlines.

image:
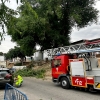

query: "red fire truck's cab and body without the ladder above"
xmin=51 ymin=53 xmax=100 ymax=91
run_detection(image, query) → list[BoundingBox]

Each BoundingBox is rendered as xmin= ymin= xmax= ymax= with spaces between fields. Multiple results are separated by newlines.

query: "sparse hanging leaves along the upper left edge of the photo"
xmin=0 ymin=0 xmax=17 ymax=41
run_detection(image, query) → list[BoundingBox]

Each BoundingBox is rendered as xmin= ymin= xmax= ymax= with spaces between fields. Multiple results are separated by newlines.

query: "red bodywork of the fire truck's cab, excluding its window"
xmin=51 ymin=55 xmax=70 ymax=78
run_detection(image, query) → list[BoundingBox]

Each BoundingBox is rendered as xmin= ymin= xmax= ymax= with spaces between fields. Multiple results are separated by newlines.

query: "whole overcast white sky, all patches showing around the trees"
xmin=0 ymin=0 xmax=100 ymax=53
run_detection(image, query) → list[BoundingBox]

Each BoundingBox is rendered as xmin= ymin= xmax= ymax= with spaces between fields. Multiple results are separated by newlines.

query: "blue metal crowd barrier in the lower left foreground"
xmin=4 ymin=83 xmax=28 ymax=100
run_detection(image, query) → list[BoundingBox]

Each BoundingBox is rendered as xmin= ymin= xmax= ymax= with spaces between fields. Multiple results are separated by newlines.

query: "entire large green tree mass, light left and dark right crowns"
xmin=7 ymin=0 xmax=98 ymax=55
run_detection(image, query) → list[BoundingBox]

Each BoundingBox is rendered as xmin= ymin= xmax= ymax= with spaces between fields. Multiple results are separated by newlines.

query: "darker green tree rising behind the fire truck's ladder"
xmin=28 ymin=0 xmax=98 ymax=48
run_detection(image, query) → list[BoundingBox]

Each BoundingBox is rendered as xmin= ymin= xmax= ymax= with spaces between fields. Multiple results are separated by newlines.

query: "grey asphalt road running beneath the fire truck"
xmin=0 ymin=78 xmax=100 ymax=100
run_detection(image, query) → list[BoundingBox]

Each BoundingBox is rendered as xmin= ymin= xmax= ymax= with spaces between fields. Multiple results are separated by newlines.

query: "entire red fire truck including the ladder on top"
xmin=47 ymin=41 xmax=100 ymax=91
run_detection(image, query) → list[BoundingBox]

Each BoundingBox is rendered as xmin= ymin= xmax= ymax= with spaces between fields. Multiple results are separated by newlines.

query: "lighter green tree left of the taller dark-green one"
xmin=7 ymin=3 xmax=40 ymax=56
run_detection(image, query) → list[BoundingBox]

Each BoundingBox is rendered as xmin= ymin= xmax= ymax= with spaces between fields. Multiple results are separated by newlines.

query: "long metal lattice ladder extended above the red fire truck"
xmin=44 ymin=40 xmax=100 ymax=56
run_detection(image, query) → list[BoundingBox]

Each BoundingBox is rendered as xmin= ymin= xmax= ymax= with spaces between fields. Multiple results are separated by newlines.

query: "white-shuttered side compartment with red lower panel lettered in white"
xmin=69 ymin=59 xmax=86 ymax=87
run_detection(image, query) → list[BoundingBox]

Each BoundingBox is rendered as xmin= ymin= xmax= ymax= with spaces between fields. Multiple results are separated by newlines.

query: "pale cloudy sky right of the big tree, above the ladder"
xmin=71 ymin=0 xmax=100 ymax=42
